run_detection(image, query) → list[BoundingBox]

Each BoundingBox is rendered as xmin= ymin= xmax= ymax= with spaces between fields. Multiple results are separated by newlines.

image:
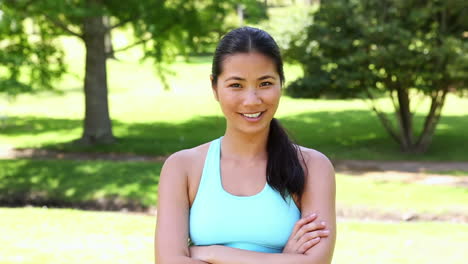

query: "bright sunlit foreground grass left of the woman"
xmin=0 ymin=208 xmax=155 ymax=264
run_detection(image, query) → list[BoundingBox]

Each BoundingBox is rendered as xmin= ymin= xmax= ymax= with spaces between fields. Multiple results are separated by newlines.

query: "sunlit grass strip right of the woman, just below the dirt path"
xmin=336 ymin=172 xmax=468 ymax=214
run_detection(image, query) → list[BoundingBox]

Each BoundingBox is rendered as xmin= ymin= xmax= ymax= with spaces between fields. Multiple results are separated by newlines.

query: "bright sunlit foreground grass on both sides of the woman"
xmin=0 ymin=208 xmax=468 ymax=264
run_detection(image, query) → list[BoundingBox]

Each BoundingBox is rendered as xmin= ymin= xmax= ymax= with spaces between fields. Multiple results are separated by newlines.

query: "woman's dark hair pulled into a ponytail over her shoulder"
xmin=211 ymin=27 xmax=305 ymax=198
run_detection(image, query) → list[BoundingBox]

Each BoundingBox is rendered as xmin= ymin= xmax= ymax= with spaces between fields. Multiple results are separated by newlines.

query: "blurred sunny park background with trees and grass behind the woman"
xmin=0 ymin=0 xmax=468 ymax=264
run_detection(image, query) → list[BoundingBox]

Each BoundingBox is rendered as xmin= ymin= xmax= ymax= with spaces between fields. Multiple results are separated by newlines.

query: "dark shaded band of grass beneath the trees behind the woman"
xmin=0 ymin=111 xmax=468 ymax=161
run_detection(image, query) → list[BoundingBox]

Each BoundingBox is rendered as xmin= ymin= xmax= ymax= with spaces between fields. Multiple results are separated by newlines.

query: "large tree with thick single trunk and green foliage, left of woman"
xmin=0 ymin=0 xmax=257 ymax=144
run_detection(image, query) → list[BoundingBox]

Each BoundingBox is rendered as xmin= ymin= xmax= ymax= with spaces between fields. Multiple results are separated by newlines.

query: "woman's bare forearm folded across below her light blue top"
xmin=207 ymin=245 xmax=326 ymax=264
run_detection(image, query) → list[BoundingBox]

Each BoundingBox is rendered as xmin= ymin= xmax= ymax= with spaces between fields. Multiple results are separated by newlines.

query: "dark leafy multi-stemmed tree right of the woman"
xmin=285 ymin=0 xmax=468 ymax=153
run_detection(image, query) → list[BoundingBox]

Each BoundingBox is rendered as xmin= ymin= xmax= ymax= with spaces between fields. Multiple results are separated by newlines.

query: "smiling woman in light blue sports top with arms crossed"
xmin=155 ymin=27 xmax=336 ymax=264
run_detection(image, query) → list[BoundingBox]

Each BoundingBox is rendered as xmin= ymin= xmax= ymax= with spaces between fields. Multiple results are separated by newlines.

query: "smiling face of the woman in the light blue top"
xmin=213 ymin=52 xmax=281 ymax=134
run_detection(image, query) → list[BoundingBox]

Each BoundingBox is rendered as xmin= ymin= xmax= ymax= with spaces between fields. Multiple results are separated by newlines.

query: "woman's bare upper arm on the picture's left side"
xmin=155 ymin=150 xmax=206 ymax=264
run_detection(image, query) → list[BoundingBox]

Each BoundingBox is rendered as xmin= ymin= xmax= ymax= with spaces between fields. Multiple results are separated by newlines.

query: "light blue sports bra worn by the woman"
xmin=189 ymin=137 xmax=301 ymax=253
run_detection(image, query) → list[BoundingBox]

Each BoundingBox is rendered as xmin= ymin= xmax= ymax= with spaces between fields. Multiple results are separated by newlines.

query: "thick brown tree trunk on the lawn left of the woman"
xmin=78 ymin=16 xmax=115 ymax=144
